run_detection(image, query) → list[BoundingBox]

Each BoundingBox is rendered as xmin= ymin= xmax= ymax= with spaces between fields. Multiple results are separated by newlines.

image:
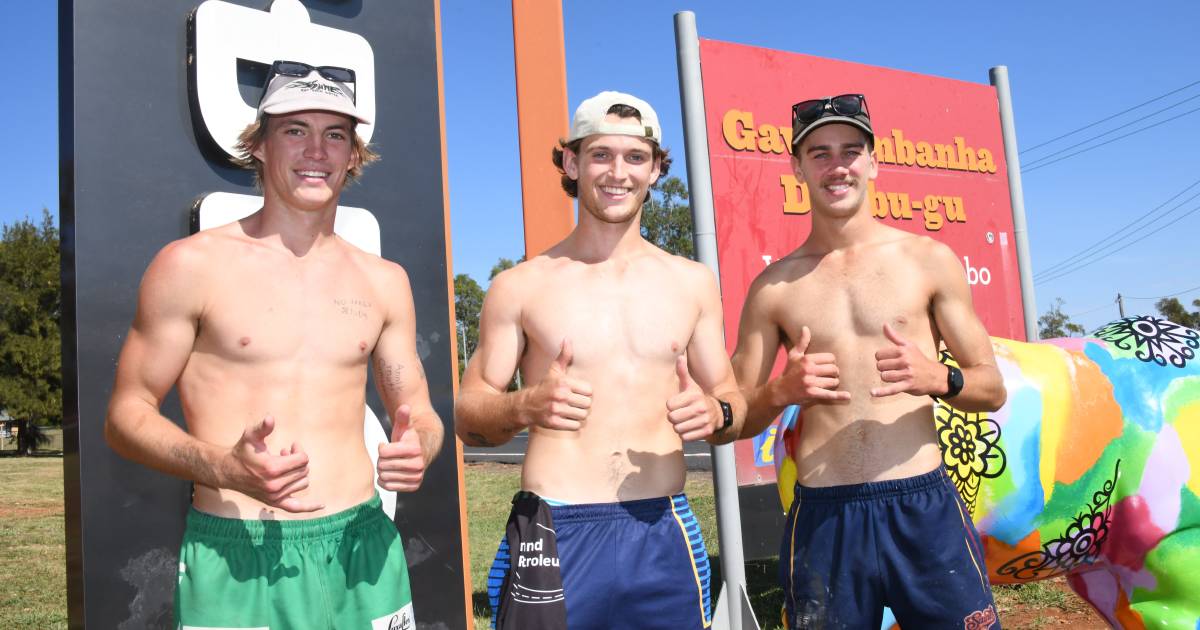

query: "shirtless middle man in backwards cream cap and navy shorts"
xmin=455 ymin=92 xmax=744 ymax=630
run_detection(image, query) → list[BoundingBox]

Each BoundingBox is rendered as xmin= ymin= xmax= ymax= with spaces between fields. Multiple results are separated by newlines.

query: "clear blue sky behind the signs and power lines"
xmin=0 ymin=0 xmax=1200 ymax=329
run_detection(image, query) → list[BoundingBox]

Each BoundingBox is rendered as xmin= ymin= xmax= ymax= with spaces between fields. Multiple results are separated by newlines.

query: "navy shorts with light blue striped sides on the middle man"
xmin=487 ymin=494 xmax=713 ymax=630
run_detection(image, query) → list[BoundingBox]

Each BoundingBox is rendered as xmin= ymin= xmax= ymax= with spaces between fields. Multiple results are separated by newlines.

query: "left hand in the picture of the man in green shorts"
xmin=221 ymin=414 xmax=325 ymax=512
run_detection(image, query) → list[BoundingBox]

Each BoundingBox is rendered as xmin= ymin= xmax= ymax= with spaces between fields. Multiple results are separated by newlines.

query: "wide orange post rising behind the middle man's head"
xmin=512 ymin=0 xmax=575 ymax=258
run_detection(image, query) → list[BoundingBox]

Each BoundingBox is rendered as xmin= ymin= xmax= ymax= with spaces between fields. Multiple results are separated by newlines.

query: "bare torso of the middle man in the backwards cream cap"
xmin=510 ymin=246 xmax=707 ymax=503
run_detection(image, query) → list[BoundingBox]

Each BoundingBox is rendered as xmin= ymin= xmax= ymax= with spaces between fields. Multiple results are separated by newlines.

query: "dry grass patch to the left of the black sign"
xmin=0 ymin=456 xmax=67 ymax=629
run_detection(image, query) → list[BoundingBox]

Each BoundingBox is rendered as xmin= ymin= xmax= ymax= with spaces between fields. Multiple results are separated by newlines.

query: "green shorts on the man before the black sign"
xmin=175 ymin=496 xmax=416 ymax=630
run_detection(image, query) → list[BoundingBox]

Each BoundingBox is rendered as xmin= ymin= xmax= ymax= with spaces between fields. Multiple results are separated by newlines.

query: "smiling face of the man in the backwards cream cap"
xmin=563 ymin=114 xmax=660 ymax=223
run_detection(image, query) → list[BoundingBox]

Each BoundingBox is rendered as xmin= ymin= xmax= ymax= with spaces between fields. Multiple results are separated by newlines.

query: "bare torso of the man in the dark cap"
xmin=767 ymin=230 xmax=941 ymax=486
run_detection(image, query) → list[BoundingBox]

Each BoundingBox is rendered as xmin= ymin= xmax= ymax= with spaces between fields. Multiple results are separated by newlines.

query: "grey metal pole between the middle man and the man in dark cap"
xmin=674 ymin=11 xmax=758 ymax=630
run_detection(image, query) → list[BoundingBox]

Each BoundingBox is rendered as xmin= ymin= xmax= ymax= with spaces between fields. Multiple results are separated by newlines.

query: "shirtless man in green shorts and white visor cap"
xmin=104 ymin=61 xmax=443 ymax=629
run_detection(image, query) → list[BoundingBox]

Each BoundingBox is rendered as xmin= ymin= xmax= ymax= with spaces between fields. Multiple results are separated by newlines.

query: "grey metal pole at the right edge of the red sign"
xmin=988 ymin=66 xmax=1038 ymax=342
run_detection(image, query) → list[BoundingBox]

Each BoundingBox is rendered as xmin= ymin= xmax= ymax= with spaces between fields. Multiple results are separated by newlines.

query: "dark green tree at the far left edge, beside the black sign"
xmin=0 ymin=209 xmax=62 ymax=454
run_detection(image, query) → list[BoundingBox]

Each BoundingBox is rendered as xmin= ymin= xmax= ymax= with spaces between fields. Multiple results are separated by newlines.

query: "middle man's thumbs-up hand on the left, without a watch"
xmin=518 ymin=340 xmax=592 ymax=431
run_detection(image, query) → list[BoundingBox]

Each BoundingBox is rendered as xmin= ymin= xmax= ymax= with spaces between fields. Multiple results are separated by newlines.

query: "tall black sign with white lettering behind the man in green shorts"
xmin=59 ymin=0 xmax=468 ymax=628
